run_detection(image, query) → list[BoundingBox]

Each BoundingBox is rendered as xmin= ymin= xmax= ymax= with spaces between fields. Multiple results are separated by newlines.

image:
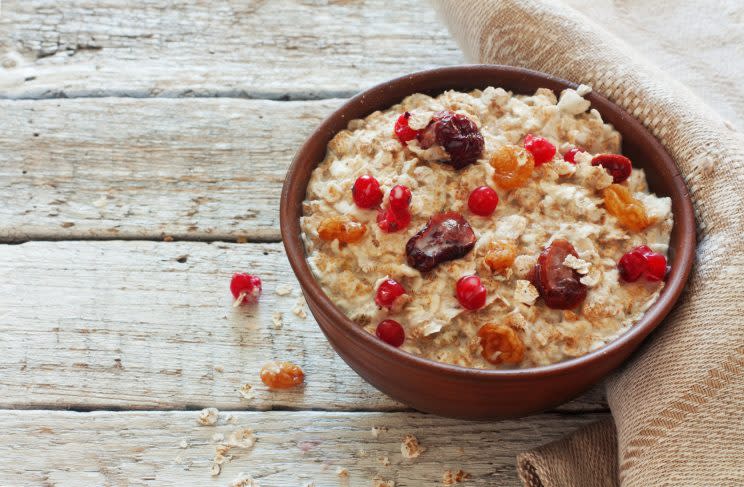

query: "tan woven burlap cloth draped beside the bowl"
xmin=432 ymin=0 xmax=744 ymax=487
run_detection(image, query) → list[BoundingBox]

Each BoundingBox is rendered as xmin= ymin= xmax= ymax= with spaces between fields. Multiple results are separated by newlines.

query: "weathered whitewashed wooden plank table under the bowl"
xmin=0 ymin=0 xmax=607 ymax=487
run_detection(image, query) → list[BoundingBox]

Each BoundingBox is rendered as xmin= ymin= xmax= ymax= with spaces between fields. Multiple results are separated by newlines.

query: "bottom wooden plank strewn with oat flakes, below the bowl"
xmin=0 ymin=411 xmax=606 ymax=487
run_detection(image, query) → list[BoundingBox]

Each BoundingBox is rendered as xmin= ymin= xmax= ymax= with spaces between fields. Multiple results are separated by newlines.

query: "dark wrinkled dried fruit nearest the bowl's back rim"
xmin=418 ymin=111 xmax=485 ymax=169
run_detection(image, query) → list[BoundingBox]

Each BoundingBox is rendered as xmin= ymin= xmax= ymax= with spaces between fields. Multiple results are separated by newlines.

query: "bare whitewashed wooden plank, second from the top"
xmin=0 ymin=98 xmax=341 ymax=241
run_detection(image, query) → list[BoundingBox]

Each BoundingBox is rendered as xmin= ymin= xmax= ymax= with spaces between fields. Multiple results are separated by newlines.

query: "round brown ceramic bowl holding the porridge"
xmin=280 ymin=65 xmax=695 ymax=418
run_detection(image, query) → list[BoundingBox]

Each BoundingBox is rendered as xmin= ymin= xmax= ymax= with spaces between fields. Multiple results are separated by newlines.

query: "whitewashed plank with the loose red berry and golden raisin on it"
xmin=0 ymin=241 xmax=606 ymax=411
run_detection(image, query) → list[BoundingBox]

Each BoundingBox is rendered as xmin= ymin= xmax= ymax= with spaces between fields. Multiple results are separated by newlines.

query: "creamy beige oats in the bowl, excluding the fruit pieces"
xmin=301 ymin=86 xmax=672 ymax=368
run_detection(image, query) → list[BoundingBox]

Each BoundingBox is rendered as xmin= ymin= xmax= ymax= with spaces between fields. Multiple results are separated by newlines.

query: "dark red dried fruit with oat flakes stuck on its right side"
xmin=533 ymin=240 xmax=586 ymax=309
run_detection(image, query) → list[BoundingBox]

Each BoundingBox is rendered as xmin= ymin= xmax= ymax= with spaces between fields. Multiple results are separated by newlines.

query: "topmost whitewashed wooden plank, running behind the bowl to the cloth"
xmin=0 ymin=0 xmax=463 ymax=99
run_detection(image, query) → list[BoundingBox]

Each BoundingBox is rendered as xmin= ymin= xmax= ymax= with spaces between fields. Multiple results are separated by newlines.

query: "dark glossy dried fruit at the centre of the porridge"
xmin=406 ymin=211 xmax=476 ymax=272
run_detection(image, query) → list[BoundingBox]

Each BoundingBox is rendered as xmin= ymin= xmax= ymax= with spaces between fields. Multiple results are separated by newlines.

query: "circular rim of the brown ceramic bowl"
xmin=279 ymin=64 xmax=696 ymax=381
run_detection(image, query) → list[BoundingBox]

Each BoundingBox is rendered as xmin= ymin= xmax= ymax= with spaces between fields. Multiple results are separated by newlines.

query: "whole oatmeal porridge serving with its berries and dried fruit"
xmin=301 ymin=86 xmax=673 ymax=368
